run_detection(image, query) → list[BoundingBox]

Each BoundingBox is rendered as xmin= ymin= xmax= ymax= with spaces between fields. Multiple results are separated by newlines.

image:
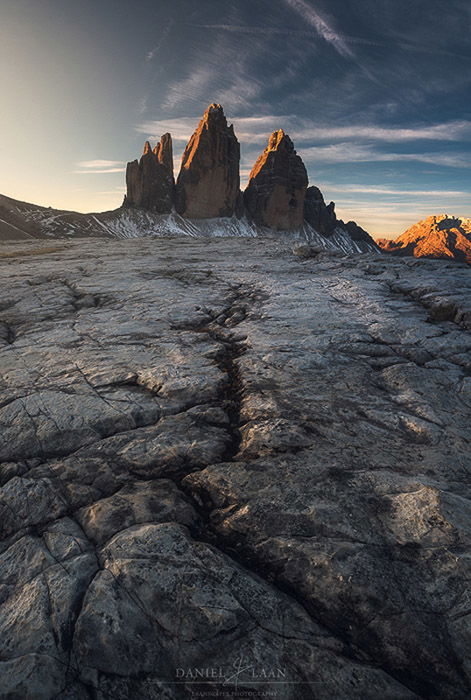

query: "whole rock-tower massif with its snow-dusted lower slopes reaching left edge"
xmin=0 ymin=104 xmax=379 ymax=253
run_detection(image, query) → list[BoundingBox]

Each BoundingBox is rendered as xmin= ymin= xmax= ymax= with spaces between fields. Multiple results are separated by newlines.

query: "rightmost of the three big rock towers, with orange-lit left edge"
xmin=244 ymin=129 xmax=308 ymax=231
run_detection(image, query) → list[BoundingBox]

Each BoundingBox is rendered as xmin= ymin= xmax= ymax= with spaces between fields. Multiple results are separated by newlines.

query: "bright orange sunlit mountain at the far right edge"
xmin=376 ymin=214 xmax=471 ymax=263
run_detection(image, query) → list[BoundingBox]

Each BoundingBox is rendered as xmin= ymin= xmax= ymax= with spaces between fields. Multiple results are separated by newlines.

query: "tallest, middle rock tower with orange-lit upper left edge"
xmin=176 ymin=104 xmax=240 ymax=219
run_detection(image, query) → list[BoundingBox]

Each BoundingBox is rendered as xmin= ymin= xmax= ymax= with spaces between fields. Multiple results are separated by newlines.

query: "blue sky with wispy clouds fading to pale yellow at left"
xmin=0 ymin=0 xmax=471 ymax=237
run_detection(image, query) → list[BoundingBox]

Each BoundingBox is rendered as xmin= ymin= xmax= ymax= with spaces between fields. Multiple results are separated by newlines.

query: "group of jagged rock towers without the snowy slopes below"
xmin=119 ymin=102 xmax=375 ymax=250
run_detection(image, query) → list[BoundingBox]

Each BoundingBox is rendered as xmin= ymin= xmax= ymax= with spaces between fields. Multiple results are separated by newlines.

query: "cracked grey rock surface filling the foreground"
xmin=0 ymin=239 xmax=471 ymax=700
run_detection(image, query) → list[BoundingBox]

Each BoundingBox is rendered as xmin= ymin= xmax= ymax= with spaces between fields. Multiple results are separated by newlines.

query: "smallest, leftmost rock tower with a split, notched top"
xmin=124 ymin=134 xmax=175 ymax=214
